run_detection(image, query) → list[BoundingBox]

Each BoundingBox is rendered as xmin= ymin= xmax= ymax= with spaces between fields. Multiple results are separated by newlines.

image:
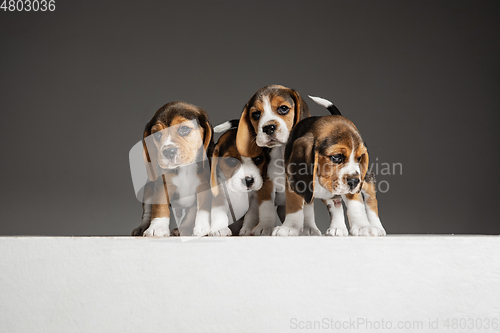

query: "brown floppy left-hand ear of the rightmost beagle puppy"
xmin=286 ymin=135 xmax=318 ymax=203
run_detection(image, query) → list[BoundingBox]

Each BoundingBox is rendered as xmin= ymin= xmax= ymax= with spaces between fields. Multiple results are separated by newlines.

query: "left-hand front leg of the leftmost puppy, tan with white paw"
xmin=143 ymin=176 xmax=170 ymax=237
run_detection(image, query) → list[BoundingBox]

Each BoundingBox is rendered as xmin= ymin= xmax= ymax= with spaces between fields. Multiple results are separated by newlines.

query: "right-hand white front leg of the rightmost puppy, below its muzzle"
xmin=342 ymin=193 xmax=382 ymax=236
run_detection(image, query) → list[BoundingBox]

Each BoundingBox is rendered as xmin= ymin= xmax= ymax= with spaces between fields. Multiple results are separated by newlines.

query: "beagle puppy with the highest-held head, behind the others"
xmin=236 ymin=85 xmax=310 ymax=236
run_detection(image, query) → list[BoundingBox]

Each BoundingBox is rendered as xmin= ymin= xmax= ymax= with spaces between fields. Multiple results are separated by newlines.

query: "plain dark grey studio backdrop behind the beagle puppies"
xmin=0 ymin=0 xmax=500 ymax=235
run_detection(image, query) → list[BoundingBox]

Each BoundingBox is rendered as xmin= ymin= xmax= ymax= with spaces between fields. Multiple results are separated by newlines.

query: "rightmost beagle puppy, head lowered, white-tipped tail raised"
xmin=273 ymin=97 xmax=386 ymax=236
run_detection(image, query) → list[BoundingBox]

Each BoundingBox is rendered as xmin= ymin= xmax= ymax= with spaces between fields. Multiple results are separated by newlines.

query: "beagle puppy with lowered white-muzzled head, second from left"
xmin=209 ymin=120 xmax=269 ymax=236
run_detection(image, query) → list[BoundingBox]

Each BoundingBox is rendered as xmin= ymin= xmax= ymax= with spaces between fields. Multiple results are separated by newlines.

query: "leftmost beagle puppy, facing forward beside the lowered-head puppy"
xmin=132 ymin=102 xmax=213 ymax=237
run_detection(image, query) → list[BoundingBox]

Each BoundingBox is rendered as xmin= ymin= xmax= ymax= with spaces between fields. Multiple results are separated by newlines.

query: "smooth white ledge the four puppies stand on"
xmin=0 ymin=236 xmax=500 ymax=332
